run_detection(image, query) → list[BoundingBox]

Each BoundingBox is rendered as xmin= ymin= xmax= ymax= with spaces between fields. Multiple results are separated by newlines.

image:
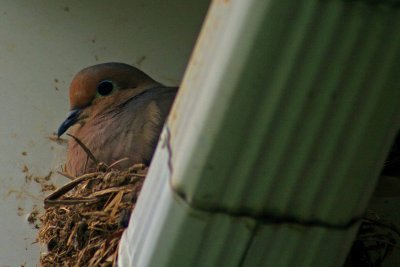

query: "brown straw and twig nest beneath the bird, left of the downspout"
xmin=38 ymin=165 xmax=147 ymax=266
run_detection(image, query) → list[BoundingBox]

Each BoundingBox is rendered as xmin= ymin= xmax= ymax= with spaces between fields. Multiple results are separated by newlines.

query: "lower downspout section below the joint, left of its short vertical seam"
xmin=119 ymin=148 xmax=256 ymax=267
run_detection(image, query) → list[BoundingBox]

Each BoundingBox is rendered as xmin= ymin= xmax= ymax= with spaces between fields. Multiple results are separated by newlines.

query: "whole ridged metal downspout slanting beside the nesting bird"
xmin=119 ymin=0 xmax=400 ymax=267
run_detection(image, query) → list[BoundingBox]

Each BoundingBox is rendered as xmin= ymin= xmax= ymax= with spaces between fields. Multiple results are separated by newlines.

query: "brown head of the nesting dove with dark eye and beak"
xmin=57 ymin=63 xmax=160 ymax=136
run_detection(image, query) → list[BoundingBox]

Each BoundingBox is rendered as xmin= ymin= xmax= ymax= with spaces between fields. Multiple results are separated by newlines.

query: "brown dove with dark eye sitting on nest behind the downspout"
xmin=57 ymin=62 xmax=178 ymax=177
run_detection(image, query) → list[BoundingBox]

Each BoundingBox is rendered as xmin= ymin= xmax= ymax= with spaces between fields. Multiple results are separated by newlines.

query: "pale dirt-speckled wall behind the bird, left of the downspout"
xmin=0 ymin=0 xmax=208 ymax=266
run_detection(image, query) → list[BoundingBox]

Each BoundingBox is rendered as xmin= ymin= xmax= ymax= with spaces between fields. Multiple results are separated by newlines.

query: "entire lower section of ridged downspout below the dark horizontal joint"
xmin=119 ymin=142 xmax=358 ymax=267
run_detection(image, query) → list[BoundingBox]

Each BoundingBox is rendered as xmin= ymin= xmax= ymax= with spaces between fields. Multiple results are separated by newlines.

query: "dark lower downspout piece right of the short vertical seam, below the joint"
xmin=240 ymin=224 xmax=357 ymax=267
